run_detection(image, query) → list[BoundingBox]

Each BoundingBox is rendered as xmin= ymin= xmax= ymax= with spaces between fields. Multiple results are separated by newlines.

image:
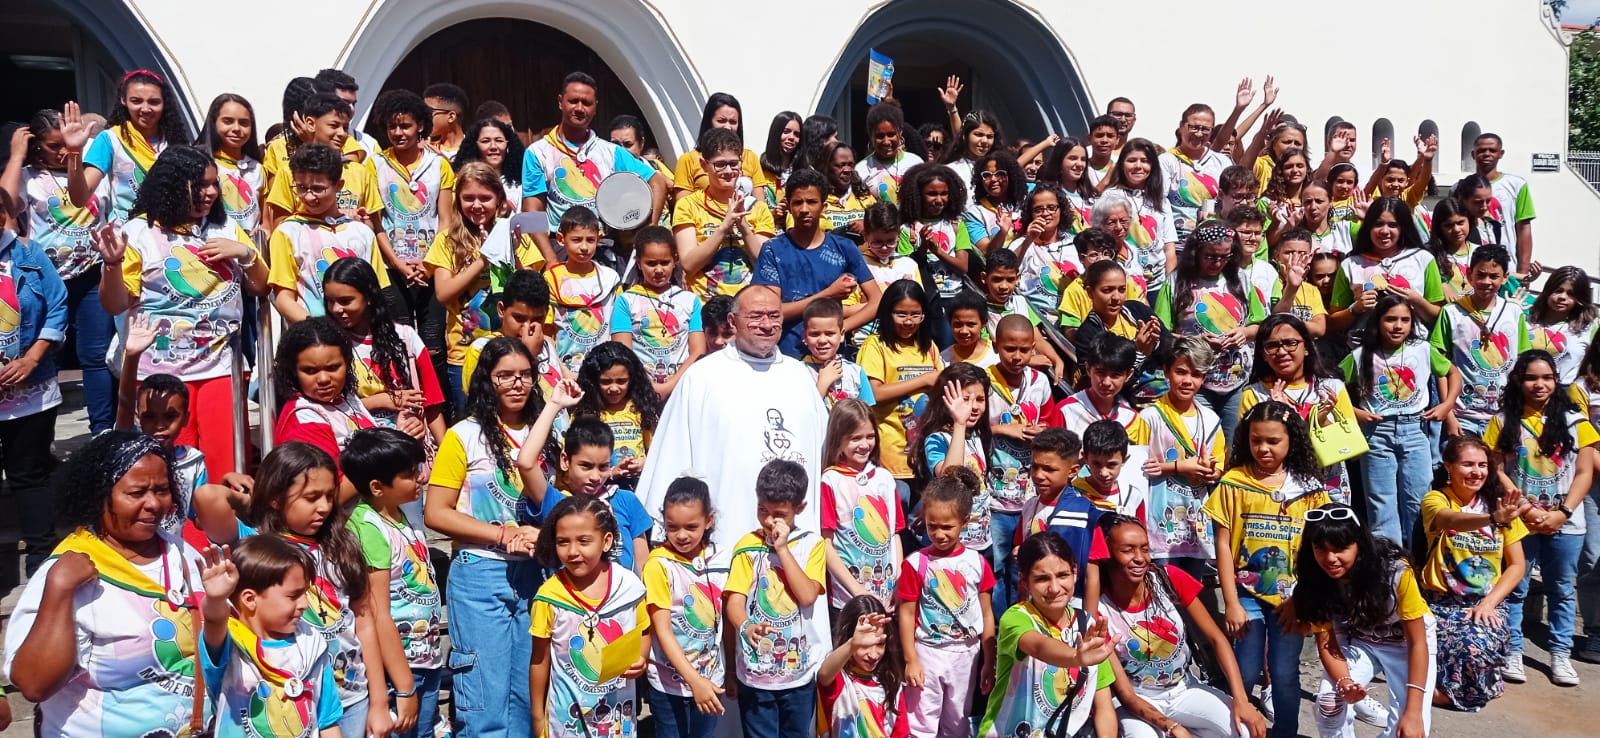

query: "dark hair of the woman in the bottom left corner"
xmin=51 ymin=429 xmax=178 ymax=530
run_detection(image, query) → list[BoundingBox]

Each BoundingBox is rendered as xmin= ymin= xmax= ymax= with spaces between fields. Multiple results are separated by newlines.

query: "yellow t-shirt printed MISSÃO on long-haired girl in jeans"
xmin=1203 ymin=467 xmax=1331 ymax=607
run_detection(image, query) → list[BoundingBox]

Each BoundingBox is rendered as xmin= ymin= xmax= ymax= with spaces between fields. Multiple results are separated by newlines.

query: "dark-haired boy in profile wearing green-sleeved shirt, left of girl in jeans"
xmin=339 ymin=427 xmax=445 ymax=738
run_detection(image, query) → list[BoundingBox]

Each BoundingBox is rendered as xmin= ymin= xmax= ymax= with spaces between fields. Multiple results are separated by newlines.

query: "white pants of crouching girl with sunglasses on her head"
xmin=1312 ymin=627 xmax=1438 ymax=738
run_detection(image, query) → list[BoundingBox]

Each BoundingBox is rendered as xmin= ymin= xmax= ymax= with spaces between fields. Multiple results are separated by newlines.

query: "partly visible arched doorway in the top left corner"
xmin=0 ymin=0 xmax=197 ymax=131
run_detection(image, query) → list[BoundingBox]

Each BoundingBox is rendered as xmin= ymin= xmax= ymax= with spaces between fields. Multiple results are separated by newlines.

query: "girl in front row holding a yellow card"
xmin=528 ymin=495 xmax=654 ymax=738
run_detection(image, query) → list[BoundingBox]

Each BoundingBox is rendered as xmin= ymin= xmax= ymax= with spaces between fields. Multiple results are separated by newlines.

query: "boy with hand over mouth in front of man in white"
xmin=723 ymin=459 xmax=829 ymax=738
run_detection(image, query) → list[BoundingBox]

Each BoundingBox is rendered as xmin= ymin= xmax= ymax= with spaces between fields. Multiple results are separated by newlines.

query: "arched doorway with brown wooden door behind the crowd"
xmin=339 ymin=0 xmax=706 ymax=162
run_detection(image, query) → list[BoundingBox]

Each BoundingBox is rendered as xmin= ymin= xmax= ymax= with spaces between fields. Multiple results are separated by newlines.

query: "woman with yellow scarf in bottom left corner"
xmin=5 ymin=431 xmax=212 ymax=738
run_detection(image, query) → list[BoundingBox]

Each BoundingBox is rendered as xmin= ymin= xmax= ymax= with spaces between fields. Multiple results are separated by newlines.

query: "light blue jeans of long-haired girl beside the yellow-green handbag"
xmin=1357 ymin=416 xmax=1434 ymax=547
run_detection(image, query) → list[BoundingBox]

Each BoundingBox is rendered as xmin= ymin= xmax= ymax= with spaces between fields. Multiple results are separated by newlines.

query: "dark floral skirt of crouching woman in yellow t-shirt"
xmin=1424 ymin=592 xmax=1510 ymax=712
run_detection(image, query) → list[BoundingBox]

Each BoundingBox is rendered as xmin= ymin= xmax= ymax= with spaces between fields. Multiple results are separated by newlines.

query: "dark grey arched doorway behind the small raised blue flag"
xmin=816 ymin=0 xmax=1094 ymax=147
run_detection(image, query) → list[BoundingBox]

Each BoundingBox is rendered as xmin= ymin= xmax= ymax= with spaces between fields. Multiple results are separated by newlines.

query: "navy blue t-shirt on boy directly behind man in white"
xmin=750 ymin=232 xmax=872 ymax=359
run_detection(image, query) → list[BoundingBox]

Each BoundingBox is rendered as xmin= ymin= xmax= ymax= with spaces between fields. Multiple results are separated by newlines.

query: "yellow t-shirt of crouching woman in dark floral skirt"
xmin=1422 ymin=490 xmax=1528 ymax=596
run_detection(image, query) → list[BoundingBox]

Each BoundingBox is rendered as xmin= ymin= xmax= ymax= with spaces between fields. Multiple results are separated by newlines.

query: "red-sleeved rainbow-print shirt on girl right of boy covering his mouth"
xmin=821 ymin=463 xmax=906 ymax=612
